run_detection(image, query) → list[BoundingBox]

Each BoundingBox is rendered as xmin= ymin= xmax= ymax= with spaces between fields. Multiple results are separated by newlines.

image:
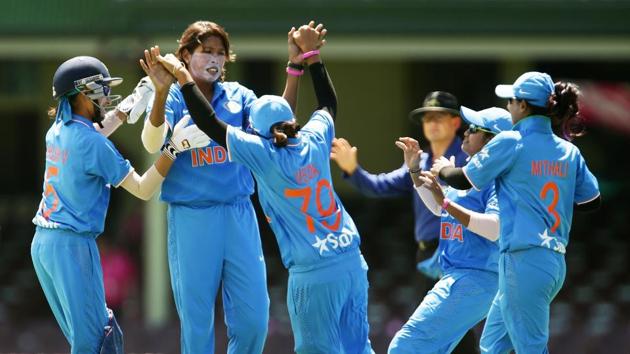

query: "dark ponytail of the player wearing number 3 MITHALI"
xmin=547 ymin=81 xmax=584 ymax=141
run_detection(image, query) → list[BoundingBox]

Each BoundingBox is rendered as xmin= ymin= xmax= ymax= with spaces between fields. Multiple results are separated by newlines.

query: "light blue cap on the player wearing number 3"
xmin=494 ymin=71 xmax=554 ymax=107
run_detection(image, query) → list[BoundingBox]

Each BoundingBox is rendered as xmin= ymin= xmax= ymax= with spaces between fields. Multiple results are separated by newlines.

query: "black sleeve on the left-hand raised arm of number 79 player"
xmin=181 ymin=82 xmax=227 ymax=147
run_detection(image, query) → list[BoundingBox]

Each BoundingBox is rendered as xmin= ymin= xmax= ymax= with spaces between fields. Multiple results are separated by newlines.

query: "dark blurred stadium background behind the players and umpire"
xmin=0 ymin=0 xmax=630 ymax=354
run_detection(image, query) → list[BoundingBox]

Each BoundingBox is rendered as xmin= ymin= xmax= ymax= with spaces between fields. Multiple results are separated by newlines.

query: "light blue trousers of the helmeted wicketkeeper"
xmin=31 ymin=227 xmax=109 ymax=354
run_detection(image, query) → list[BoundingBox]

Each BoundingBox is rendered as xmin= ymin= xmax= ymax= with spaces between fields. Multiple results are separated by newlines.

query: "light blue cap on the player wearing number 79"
xmin=249 ymin=95 xmax=294 ymax=138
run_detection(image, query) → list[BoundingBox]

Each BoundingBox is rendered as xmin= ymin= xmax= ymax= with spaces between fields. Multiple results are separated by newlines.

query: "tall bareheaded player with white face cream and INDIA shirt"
xmin=142 ymin=21 xmax=322 ymax=354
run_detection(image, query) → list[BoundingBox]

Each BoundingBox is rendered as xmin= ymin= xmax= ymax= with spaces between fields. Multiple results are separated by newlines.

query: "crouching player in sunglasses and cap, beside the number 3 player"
xmin=388 ymin=106 xmax=512 ymax=354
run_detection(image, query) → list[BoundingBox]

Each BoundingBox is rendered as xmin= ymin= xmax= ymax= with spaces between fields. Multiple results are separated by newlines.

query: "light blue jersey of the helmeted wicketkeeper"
xmin=33 ymin=114 xmax=133 ymax=237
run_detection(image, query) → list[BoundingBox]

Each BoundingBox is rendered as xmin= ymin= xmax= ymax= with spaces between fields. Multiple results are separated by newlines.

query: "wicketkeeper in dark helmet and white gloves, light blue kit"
xmin=31 ymin=56 xmax=208 ymax=354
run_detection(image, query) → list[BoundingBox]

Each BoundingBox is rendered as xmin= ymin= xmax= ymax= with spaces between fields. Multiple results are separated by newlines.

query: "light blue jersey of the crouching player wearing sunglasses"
xmin=438 ymin=184 xmax=499 ymax=274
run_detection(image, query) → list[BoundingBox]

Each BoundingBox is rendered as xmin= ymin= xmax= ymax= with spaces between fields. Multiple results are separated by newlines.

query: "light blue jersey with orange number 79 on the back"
xmin=227 ymin=110 xmax=361 ymax=271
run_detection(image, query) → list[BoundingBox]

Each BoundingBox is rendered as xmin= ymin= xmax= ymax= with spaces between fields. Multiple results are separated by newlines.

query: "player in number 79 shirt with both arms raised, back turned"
xmin=144 ymin=25 xmax=372 ymax=353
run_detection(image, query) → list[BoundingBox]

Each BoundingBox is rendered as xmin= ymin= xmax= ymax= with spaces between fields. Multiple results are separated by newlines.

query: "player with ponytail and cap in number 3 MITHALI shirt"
xmin=432 ymin=72 xmax=600 ymax=353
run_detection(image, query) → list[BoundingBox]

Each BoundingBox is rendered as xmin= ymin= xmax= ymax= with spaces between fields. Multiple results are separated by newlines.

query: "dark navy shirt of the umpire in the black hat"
xmin=344 ymin=136 xmax=468 ymax=242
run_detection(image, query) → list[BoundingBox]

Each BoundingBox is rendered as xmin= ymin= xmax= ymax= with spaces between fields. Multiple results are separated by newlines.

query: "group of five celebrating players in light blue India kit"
xmin=31 ymin=21 xmax=600 ymax=354
